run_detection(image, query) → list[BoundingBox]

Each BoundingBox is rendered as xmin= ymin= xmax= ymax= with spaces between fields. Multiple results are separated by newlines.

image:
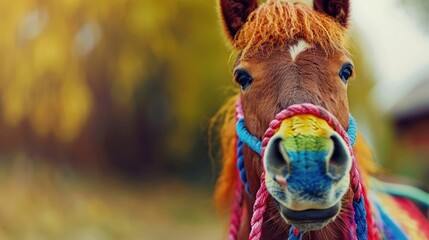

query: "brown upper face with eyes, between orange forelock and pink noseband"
xmin=234 ymin=47 xmax=353 ymax=130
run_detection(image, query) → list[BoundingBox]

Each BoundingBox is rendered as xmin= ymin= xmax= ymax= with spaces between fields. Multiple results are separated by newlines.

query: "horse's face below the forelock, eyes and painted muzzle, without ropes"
xmin=235 ymin=42 xmax=351 ymax=230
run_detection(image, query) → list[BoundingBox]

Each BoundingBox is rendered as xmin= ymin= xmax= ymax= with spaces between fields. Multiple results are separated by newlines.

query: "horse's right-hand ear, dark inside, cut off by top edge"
xmin=313 ymin=0 xmax=350 ymax=27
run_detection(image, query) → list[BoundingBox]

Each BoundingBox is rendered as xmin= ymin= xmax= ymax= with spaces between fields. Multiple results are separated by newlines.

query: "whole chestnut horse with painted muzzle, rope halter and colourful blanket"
xmin=215 ymin=0 xmax=429 ymax=240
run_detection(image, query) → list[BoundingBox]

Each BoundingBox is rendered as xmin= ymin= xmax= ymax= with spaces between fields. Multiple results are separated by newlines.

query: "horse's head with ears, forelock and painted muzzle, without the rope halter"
xmin=221 ymin=0 xmax=353 ymax=230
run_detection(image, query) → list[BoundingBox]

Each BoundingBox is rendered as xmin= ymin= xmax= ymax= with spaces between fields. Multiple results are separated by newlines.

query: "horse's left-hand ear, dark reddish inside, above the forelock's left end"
xmin=220 ymin=0 xmax=258 ymax=41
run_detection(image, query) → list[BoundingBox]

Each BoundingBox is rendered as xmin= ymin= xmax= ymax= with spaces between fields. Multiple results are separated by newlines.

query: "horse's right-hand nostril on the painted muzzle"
xmin=327 ymin=133 xmax=351 ymax=179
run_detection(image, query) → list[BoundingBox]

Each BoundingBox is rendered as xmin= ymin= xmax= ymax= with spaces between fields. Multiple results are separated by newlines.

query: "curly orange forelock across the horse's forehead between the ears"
xmin=233 ymin=0 xmax=347 ymax=57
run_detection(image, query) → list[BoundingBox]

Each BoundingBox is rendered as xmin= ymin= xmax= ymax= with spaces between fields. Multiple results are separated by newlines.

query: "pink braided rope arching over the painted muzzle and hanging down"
xmin=244 ymin=101 xmax=363 ymax=240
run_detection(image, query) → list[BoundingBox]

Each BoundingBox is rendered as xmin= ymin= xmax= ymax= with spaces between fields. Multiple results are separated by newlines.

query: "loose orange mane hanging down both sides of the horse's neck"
xmin=212 ymin=95 xmax=378 ymax=214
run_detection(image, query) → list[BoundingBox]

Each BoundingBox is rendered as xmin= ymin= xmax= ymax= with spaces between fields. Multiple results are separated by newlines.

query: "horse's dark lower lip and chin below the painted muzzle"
xmin=279 ymin=202 xmax=341 ymax=231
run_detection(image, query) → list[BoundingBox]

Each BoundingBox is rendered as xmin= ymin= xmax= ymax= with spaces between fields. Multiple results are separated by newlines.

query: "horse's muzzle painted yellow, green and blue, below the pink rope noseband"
xmin=264 ymin=114 xmax=352 ymax=231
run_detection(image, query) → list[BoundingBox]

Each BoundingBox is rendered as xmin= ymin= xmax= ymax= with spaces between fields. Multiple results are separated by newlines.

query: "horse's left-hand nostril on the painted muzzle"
xmin=264 ymin=136 xmax=289 ymax=182
